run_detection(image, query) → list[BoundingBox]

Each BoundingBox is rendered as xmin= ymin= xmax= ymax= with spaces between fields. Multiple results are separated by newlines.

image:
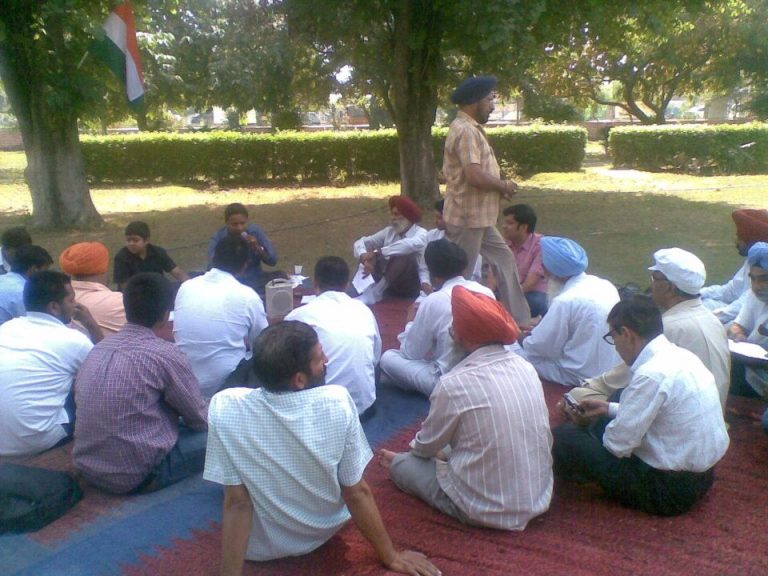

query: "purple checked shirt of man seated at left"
xmin=72 ymin=324 xmax=208 ymax=493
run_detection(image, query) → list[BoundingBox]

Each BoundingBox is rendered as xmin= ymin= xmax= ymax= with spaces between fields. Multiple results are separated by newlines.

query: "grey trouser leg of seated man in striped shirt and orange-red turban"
xmin=389 ymin=452 xmax=474 ymax=525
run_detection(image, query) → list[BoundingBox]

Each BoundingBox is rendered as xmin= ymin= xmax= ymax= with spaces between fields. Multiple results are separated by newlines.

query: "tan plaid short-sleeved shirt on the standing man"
xmin=443 ymin=111 xmax=501 ymax=228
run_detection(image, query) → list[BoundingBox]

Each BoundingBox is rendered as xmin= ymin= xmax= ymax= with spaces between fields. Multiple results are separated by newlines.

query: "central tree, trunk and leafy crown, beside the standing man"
xmin=283 ymin=0 xmax=548 ymax=203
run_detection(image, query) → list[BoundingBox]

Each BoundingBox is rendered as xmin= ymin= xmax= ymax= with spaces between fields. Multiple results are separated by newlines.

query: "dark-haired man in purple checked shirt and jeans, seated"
xmin=72 ymin=272 xmax=207 ymax=494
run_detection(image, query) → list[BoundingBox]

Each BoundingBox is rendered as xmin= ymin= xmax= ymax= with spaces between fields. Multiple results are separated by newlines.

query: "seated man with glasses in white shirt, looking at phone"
xmin=553 ymin=296 xmax=729 ymax=516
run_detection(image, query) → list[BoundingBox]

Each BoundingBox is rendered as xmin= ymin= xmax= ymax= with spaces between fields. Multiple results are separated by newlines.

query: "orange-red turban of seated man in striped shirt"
xmin=451 ymin=286 xmax=520 ymax=344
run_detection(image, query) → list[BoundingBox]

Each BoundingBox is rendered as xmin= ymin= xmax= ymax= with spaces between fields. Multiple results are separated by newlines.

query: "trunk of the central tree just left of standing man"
xmin=391 ymin=0 xmax=443 ymax=206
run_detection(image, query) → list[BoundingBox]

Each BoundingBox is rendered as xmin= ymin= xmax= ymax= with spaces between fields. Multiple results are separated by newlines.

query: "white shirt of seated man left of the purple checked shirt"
xmin=0 ymin=312 xmax=93 ymax=456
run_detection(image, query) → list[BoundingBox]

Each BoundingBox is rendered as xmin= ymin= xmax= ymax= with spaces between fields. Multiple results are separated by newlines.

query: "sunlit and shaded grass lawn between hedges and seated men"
xmin=0 ymin=151 xmax=768 ymax=286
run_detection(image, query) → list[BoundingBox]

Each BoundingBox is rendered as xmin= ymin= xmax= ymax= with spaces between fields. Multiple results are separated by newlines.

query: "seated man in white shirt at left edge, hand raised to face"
xmin=0 ymin=271 xmax=102 ymax=456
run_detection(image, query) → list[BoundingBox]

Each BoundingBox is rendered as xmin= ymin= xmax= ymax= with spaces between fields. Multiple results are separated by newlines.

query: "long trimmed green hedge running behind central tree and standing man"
xmin=82 ymin=126 xmax=587 ymax=183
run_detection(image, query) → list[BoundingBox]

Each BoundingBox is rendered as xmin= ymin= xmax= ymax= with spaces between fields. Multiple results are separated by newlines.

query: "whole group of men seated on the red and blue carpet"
xmin=0 ymin=196 xmax=768 ymax=574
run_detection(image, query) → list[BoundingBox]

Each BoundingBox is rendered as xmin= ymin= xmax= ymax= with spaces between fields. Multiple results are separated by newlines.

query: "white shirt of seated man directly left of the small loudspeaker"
xmin=173 ymin=268 xmax=267 ymax=398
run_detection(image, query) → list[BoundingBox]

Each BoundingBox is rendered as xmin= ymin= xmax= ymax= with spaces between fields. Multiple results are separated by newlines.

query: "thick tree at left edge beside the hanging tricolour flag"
xmin=0 ymin=0 xmax=106 ymax=227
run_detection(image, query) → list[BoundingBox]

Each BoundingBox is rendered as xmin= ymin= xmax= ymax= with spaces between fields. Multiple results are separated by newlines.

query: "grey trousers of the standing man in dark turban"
xmin=445 ymin=224 xmax=531 ymax=326
